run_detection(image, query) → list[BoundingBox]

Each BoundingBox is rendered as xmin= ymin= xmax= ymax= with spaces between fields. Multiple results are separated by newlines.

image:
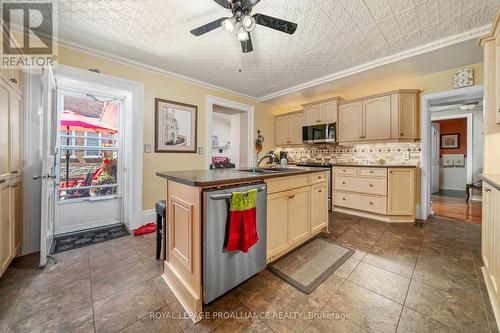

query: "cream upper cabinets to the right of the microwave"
xmin=338 ymin=90 xmax=419 ymax=143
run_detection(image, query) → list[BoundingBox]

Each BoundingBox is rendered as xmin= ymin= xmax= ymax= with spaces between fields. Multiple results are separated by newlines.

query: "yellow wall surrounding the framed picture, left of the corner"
xmin=58 ymin=47 xmax=274 ymax=210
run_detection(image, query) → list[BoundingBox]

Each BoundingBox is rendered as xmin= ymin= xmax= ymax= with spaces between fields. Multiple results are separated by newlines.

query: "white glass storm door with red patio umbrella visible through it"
xmin=54 ymin=89 xmax=124 ymax=235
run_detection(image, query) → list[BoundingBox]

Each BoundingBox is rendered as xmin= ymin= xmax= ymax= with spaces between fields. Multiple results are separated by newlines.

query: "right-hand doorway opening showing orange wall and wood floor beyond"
xmin=428 ymin=91 xmax=484 ymax=224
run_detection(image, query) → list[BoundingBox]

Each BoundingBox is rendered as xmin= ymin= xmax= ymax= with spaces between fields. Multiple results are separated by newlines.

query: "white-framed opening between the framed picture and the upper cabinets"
xmin=206 ymin=96 xmax=254 ymax=168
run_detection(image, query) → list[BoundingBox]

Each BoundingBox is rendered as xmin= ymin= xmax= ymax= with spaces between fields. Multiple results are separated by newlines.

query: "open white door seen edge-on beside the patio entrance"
xmin=39 ymin=67 xmax=57 ymax=266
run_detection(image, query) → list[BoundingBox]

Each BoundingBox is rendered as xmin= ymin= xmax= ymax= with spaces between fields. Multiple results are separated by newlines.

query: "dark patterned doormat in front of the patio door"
xmin=51 ymin=224 xmax=130 ymax=253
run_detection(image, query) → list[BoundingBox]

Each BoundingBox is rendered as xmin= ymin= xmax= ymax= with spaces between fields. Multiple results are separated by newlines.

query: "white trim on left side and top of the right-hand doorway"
xmin=418 ymin=85 xmax=484 ymax=220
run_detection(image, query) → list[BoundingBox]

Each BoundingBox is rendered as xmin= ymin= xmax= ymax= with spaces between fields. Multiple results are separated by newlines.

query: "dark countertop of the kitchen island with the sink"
xmin=156 ymin=167 xmax=329 ymax=187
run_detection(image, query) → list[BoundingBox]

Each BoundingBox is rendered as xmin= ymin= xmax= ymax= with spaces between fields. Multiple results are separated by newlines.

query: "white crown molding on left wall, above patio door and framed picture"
xmin=58 ymin=38 xmax=258 ymax=103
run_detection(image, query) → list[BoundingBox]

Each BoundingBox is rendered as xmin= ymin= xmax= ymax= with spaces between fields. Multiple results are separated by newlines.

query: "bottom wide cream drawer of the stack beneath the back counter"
xmin=333 ymin=191 xmax=387 ymax=214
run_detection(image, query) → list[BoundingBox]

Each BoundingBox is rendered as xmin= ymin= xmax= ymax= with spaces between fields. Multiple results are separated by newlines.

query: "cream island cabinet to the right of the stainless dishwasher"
xmin=266 ymin=173 xmax=328 ymax=262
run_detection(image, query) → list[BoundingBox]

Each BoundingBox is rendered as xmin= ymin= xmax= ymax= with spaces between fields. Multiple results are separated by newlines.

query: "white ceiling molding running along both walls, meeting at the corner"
xmin=58 ymin=24 xmax=492 ymax=102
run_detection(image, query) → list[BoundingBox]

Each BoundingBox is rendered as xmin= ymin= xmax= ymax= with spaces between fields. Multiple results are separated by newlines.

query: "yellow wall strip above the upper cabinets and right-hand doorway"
xmin=274 ymin=63 xmax=484 ymax=114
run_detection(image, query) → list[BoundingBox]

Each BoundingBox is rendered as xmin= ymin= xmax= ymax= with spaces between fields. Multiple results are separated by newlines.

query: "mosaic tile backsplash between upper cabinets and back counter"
xmin=275 ymin=142 xmax=422 ymax=166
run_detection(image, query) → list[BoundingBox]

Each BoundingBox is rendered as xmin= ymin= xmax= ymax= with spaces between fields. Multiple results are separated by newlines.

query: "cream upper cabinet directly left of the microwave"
xmin=275 ymin=113 xmax=304 ymax=146
